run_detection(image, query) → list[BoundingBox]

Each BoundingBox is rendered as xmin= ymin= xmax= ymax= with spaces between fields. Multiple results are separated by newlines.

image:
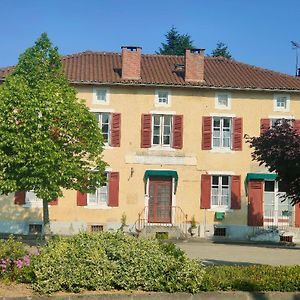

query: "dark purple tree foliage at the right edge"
xmin=247 ymin=120 xmax=300 ymax=204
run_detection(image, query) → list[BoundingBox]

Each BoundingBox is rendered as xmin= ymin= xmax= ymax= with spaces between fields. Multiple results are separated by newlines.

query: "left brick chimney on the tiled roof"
xmin=122 ymin=46 xmax=142 ymax=80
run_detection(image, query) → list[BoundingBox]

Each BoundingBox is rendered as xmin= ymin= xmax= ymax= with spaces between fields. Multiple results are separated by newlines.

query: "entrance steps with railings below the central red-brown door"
xmin=130 ymin=206 xmax=190 ymax=239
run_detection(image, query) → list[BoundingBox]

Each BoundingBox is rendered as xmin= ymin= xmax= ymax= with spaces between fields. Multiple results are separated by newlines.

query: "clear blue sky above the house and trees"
xmin=0 ymin=0 xmax=300 ymax=75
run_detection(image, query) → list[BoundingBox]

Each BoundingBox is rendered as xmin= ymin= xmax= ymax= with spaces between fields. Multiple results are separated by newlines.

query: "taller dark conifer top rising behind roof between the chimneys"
xmin=156 ymin=26 xmax=195 ymax=55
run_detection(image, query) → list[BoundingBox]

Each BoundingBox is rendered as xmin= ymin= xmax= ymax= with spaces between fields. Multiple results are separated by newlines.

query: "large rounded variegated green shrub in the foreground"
xmin=33 ymin=233 xmax=204 ymax=293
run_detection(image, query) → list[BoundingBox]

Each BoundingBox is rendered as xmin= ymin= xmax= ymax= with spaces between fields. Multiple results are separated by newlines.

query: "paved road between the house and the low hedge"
xmin=176 ymin=241 xmax=300 ymax=266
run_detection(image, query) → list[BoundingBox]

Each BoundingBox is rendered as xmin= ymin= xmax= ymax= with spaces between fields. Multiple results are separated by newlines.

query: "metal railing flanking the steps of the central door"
xmin=131 ymin=206 xmax=190 ymax=236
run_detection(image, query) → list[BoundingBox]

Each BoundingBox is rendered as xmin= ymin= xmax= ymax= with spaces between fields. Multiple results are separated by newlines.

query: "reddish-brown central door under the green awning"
xmin=148 ymin=177 xmax=172 ymax=223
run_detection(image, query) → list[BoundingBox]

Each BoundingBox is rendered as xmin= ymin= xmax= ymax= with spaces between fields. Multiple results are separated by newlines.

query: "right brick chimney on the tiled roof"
xmin=185 ymin=49 xmax=205 ymax=82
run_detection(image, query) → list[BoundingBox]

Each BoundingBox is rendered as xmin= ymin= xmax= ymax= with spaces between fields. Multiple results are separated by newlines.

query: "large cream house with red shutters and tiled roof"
xmin=0 ymin=47 xmax=300 ymax=241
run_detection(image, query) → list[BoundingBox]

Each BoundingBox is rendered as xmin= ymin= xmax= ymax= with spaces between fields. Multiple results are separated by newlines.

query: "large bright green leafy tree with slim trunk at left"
xmin=0 ymin=33 xmax=105 ymax=233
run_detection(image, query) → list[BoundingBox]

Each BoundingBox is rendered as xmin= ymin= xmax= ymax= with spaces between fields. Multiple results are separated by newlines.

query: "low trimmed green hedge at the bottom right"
xmin=201 ymin=261 xmax=300 ymax=292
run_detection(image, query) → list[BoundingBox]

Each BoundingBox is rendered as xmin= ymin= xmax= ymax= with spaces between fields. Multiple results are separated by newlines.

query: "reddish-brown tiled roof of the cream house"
xmin=0 ymin=51 xmax=300 ymax=91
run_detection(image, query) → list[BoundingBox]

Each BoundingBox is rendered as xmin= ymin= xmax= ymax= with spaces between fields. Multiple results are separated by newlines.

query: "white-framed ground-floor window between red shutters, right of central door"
xmin=211 ymin=175 xmax=231 ymax=208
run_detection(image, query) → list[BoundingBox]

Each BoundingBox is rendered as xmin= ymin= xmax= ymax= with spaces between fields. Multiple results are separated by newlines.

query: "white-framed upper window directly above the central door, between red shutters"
xmin=152 ymin=115 xmax=172 ymax=147
